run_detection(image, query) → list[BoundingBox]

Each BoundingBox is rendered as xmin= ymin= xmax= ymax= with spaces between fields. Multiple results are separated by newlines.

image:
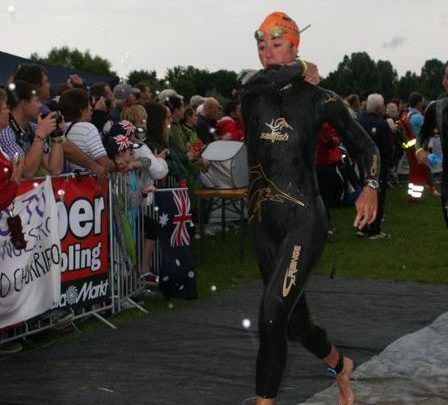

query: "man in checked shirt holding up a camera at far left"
xmin=0 ymin=80 xmax=65 ymax=178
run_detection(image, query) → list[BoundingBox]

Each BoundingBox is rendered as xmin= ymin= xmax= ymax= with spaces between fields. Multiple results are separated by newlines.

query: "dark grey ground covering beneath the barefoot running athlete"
xmin=0 ymin=277 xmax=448 ymax=405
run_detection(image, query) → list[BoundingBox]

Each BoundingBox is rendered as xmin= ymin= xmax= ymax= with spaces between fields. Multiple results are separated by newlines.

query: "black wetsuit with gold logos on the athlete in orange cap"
xmin=242 ymin=64 xmax=379 ymax=398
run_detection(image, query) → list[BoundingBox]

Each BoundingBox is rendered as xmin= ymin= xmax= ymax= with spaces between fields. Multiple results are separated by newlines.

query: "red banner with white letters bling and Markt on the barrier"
xmin=19 ymin=176 xmax=109 ymax=307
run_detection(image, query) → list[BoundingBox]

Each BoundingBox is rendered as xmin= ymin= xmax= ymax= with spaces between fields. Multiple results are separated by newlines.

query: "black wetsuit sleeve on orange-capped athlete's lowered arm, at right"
xmin=321 ymin=90 xmax=380 ymax=180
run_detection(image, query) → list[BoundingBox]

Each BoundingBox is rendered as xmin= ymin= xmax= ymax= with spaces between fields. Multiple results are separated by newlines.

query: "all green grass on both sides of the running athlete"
xmin=14 ymin=188 xmax=448 ymax=349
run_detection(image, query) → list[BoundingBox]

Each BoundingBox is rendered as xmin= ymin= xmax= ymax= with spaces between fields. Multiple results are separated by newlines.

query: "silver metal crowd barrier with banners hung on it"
xmin=0 ymin=172 xmax=182 ymax=344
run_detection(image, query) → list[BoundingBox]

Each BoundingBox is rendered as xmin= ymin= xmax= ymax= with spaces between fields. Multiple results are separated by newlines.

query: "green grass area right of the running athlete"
xmin=317 ymin=188 xmax=448 ymax=283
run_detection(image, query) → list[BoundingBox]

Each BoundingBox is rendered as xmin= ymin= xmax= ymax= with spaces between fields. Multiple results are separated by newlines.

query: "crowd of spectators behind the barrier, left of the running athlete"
xmin=0 ymin=64 xmax=244 ymax=210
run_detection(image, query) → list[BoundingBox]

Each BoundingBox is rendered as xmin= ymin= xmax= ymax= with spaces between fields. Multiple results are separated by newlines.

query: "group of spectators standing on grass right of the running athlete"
xmin=316 ymin=87 xmax=440 ymax=239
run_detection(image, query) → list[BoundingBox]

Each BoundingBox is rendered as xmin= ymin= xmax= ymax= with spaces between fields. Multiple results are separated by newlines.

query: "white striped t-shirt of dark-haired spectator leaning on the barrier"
xmin=66 ymin=122 xmax=107 ymax=171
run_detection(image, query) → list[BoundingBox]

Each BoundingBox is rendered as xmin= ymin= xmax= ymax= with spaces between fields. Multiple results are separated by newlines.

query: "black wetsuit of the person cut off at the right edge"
xmin=416 ymin=97 xmax=448 ymax=227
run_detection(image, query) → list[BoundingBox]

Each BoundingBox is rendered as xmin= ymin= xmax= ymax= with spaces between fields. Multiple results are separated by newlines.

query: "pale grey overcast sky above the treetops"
xmin=0 ymin=0 xmax=448 ymax=76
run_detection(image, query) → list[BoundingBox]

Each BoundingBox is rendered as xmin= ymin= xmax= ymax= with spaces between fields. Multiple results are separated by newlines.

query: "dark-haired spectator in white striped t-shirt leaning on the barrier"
xmin=59 ymin=88 xmax=115 ymax=172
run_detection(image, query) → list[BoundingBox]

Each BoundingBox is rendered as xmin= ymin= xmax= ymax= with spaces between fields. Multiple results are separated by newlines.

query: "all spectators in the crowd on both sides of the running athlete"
xmin=0 ymin=59 xmax=446 ymax=350
